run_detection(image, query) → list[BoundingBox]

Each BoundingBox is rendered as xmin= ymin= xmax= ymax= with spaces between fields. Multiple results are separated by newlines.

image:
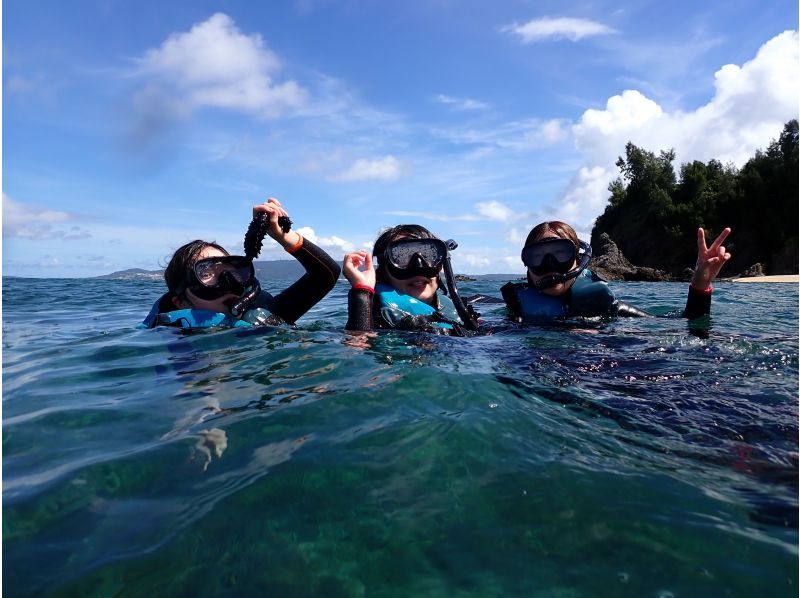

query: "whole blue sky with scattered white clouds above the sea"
xmin=3 ymin=0 xmax=800 ymax=277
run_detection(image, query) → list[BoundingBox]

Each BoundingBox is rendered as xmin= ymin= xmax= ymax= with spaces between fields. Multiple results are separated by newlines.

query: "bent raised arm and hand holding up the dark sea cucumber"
xmin=260 ymin=198 xmax=341 ymax=324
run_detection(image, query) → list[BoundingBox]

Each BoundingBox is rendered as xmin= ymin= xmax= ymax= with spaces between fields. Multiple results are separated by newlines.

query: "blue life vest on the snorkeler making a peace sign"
xmin=500 ymin=270 xmax=618 ymax=320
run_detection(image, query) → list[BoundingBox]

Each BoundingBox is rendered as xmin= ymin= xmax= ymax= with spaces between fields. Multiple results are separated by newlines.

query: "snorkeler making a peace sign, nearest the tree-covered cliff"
xmin=500 ymin=221 xmax=731 ymax=321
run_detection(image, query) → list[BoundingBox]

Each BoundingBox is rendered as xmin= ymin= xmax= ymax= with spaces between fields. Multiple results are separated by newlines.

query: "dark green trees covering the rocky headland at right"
xmin=592 ymin=120 xmax=798 ymax=274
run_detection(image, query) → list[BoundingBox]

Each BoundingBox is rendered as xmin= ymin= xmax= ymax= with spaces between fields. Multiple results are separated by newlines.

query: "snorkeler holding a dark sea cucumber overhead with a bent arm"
xmin=142 ymin=198 xmax=340 ymax=328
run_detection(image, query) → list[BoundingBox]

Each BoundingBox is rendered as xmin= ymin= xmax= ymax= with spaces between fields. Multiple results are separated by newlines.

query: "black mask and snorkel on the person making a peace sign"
xmin=522 ymin=239 xmax=592 ymax=291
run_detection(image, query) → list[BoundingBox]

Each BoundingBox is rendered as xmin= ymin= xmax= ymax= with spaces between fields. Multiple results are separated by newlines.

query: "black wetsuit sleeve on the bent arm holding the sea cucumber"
xmin=270 ymin=238 xmax=341 ymax=324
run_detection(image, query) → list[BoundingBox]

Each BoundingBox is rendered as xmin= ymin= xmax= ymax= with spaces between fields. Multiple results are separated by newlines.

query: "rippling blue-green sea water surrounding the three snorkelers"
xmin=2 ymin=278 xmax=798 ymax=598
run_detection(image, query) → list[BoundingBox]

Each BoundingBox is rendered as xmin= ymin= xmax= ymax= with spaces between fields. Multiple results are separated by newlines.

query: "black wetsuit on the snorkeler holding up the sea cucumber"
xmin=143 ymin=238 xmax=341 ymax=328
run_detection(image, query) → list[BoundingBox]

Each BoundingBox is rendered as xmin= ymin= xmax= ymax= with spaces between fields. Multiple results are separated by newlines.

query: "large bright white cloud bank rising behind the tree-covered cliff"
xmin=552 ymin=31 xmax=800 ymax=229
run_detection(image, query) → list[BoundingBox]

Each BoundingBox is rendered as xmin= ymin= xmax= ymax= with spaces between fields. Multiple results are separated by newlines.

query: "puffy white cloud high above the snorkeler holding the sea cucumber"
xmin=138 ymin=13 xmax=307 ymax=117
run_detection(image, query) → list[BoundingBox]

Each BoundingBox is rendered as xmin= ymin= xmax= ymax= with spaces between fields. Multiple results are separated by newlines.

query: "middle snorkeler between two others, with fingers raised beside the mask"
xmin=342 ymin=224 xmax=477 ymax=336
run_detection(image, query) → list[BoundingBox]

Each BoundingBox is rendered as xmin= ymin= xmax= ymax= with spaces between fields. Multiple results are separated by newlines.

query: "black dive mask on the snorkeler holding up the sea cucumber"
xmin=177 ymin=255 xmax=258 ymax=301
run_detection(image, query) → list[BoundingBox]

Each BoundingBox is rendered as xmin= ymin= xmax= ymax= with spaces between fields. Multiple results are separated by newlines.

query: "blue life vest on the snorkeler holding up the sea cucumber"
xmin=138 ymin=291 xmax=283 ymax=328
